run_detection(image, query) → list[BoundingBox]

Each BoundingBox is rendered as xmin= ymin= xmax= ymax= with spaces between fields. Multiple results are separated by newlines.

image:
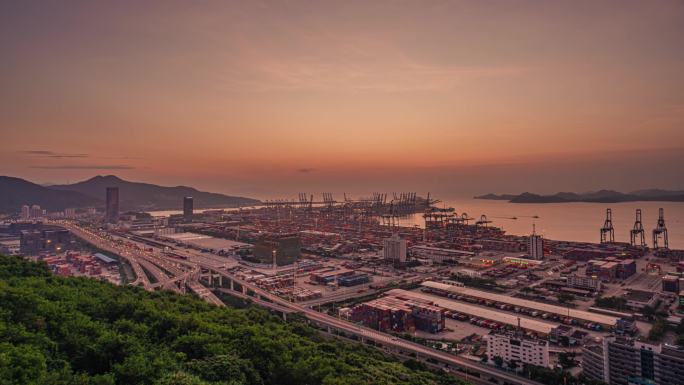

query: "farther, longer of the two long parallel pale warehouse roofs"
xmin=422 ymin=281 xmax=619 ymax=326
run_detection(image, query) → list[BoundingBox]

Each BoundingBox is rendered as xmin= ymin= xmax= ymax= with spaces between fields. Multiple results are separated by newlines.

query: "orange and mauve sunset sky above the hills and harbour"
xmin=0 ymin=0 xmax=684 ymax=197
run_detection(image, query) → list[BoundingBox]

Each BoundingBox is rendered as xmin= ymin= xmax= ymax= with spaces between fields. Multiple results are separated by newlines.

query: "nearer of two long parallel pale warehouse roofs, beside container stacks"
xmin=387 ymin=289 xmax=556 ymax=334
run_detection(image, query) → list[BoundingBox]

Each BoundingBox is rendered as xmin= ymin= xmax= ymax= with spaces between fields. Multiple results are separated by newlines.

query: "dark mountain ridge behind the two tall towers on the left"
xmin=0 ymin=175 xmax=261 ymax=213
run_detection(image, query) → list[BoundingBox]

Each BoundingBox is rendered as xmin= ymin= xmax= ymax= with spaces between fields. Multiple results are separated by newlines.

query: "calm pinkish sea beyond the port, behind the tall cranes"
xmin=151 ymin=198 xmax=684 ymax=249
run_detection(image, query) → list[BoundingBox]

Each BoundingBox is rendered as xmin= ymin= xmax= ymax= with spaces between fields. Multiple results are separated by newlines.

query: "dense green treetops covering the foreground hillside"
xmin=0 ymin=256 xmax=460 ymax=385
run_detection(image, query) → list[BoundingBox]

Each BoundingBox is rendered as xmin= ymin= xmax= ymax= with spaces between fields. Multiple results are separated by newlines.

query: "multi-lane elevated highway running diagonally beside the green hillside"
xmin=57 ymin=221 xmax=540 ymax=385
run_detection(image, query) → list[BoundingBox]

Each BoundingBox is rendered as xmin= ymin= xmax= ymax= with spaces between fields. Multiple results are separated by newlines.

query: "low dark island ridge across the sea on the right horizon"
xmin=474 ymin=189 xmax=684 ymax=203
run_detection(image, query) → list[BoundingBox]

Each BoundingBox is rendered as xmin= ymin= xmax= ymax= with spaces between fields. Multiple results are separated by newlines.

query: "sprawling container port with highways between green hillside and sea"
xmin=8 ymin=192 xmax=684 ymax=384
